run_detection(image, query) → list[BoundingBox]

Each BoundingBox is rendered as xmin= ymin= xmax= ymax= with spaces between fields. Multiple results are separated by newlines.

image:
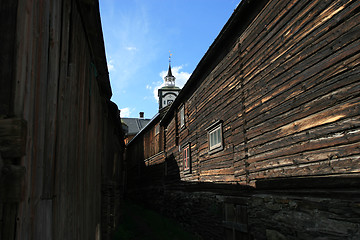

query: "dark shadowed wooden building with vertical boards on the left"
xmin=0 ymin=0 xmax=124 ymax=240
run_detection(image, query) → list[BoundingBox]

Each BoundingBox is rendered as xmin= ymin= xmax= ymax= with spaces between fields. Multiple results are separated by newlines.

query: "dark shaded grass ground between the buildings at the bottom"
xmin=114 ymin=202 xmax=199 ymax=240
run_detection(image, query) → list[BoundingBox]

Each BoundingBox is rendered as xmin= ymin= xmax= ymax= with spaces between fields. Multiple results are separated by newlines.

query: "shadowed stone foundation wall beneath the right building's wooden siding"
xmin=132 ymin=183 xmax=360 ymax=240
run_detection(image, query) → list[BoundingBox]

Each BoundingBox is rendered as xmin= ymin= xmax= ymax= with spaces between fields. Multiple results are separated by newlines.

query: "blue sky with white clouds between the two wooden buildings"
xmin=99 ymin=0 xmax=240 ymax=118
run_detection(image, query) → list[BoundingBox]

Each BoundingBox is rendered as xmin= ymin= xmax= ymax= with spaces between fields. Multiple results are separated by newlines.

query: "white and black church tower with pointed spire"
xmin=158 ymin=55 xmax=181 ymax=109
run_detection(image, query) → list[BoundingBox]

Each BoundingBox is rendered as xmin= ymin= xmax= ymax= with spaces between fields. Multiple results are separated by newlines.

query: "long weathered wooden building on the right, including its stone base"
xmin=128 ymin=0 xmax=360 ymax=239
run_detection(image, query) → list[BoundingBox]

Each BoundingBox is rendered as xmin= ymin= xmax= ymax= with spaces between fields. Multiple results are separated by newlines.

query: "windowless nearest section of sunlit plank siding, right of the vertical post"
xmin=238 ymin=1 xmax=360 ymax=185
